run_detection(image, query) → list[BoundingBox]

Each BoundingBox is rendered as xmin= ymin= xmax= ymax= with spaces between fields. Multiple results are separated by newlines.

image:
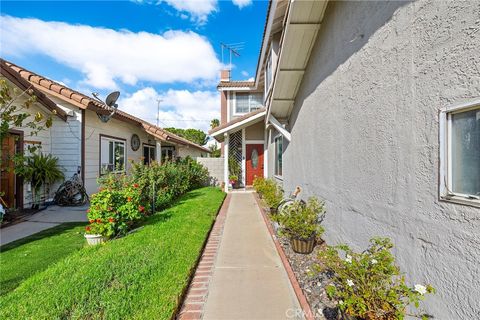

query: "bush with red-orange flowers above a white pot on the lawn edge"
xmin=86 ymin=174 xmax=148 ymax=238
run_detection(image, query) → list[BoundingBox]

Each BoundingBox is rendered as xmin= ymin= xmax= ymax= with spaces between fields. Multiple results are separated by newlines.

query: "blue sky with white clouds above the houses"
xmin=0 ymin=0 xmax=268 ymax=130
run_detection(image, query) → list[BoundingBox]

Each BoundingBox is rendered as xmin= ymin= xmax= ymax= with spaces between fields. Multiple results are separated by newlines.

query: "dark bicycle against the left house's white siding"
xmin=53 ymin=172 xmax=89 ymax=206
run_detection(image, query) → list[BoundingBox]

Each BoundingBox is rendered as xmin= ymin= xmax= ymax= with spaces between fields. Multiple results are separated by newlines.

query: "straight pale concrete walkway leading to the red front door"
xmin=203 ymin=192 xmax=302 ymax=320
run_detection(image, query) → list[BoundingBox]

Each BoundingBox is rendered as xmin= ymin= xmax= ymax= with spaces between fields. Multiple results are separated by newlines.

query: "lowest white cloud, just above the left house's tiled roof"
xmin=119 ymin=87 xmax=220 ymax=132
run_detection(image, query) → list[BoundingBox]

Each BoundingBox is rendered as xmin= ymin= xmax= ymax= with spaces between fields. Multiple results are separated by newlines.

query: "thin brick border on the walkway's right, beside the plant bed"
xmin=254 ymin=192 xmax=315 ymax=320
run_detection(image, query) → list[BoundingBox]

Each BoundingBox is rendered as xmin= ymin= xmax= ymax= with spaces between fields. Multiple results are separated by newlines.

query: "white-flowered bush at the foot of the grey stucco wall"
xmin=319 ymin=238 xmax=435 ymax=320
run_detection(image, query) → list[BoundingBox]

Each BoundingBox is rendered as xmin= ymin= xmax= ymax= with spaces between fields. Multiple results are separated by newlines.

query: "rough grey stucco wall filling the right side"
xmin=283 ymin=1 xmax=480 ymax=319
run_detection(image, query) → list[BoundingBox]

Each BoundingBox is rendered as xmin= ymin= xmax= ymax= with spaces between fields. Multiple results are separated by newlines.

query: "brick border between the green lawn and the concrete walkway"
xmin=177 ymin=194 xmax=232 ymax=320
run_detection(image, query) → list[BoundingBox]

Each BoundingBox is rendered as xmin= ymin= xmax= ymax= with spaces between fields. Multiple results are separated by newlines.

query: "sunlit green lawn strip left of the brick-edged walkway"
xmin=0 ymin=188 xmax=225 ymax=319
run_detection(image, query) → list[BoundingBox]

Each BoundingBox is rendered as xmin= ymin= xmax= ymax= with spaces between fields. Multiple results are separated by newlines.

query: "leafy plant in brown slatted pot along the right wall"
xmin=276 ymin=197 xmax=325 ymax=254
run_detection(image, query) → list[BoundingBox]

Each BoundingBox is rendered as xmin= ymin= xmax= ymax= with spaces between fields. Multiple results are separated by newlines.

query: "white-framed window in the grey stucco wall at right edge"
xmin=439 ymin=100 xmax=480 ymax=207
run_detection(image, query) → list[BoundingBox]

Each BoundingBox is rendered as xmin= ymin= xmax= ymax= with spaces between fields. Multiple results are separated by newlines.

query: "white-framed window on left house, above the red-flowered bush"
xmin=100 ymin=136 xmax=126 ymax=174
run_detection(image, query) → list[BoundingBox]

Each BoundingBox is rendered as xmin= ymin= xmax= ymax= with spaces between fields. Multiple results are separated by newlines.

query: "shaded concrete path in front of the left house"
xmin=0 ymin=205 xmax=88 ymax=245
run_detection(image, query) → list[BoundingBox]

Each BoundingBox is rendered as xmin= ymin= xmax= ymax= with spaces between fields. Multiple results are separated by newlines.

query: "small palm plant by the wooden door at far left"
xmin=15 ymin=152 xmax=65 ymax=208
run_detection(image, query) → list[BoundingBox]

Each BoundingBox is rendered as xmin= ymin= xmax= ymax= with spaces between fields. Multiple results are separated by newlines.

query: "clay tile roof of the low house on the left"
xmin=1 ymin=59 xmax=210 ymax=152
